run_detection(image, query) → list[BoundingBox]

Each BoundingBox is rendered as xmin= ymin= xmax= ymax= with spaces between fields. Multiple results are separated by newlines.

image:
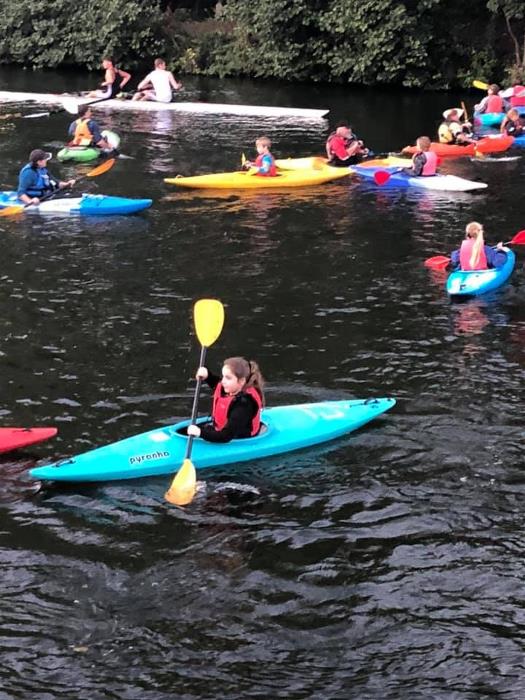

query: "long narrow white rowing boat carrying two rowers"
xmin=0 ymin=90 xmax=329 ymax=119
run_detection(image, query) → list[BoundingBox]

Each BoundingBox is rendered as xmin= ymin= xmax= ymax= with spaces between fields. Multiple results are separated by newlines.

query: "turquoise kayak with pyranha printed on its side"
xmin=29 ymin=398 xmax=395 ymax=481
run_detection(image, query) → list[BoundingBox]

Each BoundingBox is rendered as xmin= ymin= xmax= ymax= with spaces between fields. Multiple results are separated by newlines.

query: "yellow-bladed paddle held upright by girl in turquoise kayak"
xmin=164 ymin=299 xmax=224 ymax=506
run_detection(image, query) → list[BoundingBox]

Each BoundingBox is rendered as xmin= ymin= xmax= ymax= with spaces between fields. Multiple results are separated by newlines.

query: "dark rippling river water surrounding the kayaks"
xmin=0 ymin=68 xmax=525 ymax=700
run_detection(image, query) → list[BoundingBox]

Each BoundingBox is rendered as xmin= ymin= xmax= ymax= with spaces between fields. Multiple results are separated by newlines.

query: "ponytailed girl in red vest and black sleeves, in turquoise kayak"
xmin=188 ymin=357 xmax=264 ymax=442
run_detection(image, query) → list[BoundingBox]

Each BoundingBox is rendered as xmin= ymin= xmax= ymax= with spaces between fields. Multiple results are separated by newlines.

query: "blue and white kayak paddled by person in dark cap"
xmin=0 ymin=192 xmax=153 ymax=216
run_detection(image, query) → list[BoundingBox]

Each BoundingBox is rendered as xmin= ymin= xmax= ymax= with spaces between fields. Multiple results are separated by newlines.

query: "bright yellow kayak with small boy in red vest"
xmin=164 ymin=156 xmax=350 ymax=190
